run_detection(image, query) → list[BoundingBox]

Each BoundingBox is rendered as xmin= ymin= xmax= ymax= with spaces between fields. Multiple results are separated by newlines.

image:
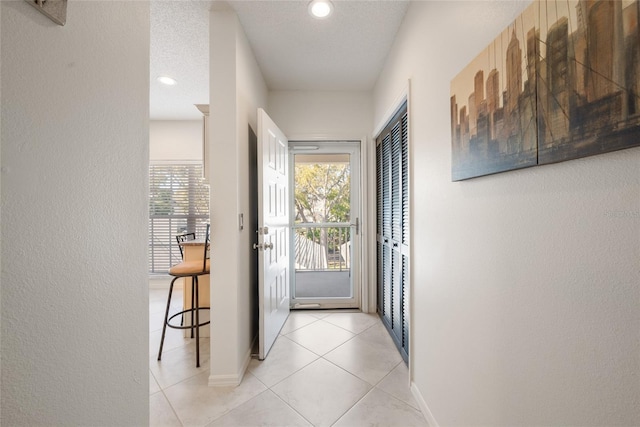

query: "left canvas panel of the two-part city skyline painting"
xmin=451 ymin=3 xmax=538 ymax=181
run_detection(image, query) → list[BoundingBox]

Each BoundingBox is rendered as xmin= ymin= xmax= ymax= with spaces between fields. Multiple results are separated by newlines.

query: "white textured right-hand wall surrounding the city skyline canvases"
xmin=374 ymin=1 xmax=640 ymax=426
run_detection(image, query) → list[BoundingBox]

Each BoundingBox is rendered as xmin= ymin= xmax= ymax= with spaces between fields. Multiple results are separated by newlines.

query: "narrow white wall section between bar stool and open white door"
xmin=209 ymin=10 xmax=267 ymax=386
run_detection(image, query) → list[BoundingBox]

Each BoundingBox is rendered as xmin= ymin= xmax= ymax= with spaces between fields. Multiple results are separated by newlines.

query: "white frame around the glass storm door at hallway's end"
xmin=288 ymin=134 xmax=368 ymax=313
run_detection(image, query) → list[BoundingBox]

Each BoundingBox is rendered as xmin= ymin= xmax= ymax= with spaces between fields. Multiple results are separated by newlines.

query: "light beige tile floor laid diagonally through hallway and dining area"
xmin=149 ymin=289 xmax=427 ymax=427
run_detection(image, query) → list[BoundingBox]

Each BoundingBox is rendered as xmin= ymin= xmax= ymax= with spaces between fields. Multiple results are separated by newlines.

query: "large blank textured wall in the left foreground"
xmin=0 ymin=1 xmax=149 ymax=426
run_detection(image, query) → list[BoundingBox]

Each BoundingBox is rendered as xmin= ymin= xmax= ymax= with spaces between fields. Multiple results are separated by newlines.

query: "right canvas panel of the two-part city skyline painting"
xmin=538 ymin=0 xmax=640 ymax=164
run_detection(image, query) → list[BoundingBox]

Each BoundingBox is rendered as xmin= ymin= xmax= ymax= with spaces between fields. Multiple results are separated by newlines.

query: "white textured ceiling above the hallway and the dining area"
xmin=150 ymin=0 xmax=408 ymax=120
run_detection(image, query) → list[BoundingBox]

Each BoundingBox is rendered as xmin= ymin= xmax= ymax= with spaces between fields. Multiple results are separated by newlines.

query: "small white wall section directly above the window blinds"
xmin=149 ymin=120 xmax=202 ymax=162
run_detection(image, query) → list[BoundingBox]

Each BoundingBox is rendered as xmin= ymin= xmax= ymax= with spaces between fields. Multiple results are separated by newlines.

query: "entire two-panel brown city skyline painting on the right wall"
xmin=450 ymin=0 xmax=640 ymax=181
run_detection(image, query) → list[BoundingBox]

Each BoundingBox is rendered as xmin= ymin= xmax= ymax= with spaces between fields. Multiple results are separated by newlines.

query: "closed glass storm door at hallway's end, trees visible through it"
xmin=289 ymin=141 xmax=360 ymax=308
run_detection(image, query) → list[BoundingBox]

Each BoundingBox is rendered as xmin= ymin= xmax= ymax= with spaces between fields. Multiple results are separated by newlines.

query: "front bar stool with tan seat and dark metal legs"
xmin=158 ymin=224 xmax=210 ymax=368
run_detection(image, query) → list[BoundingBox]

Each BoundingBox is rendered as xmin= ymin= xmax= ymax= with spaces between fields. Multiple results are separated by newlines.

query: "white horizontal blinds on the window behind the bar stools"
xmin=149 ymin=164 xmax=209 ymax=273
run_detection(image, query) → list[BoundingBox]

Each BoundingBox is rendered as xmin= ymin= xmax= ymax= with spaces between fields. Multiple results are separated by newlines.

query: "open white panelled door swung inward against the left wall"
xmin=255 ymin=108 xmax=289 ymax=360
